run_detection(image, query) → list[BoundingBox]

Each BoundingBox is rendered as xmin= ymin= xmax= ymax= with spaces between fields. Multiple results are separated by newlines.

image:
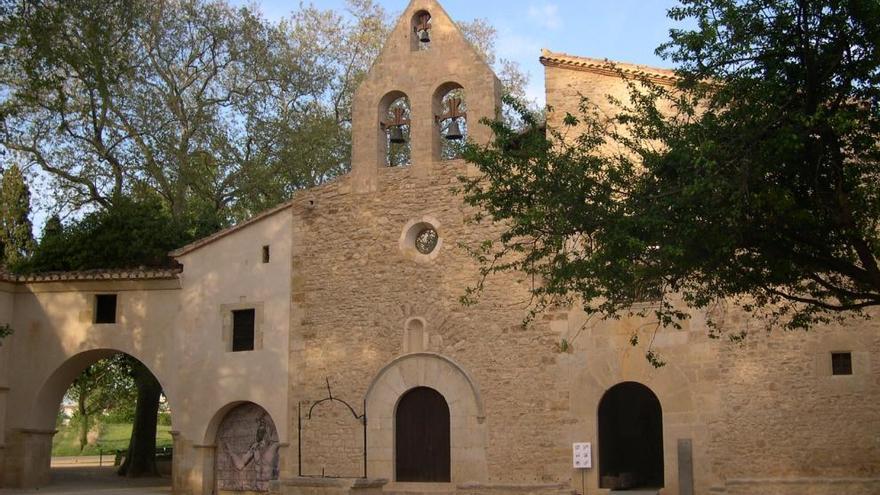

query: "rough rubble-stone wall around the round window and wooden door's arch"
xmin=290 ymin=163 xmax=568 ymax=482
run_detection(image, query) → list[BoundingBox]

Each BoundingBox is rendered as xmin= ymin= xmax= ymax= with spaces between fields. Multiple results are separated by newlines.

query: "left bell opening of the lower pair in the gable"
xmin=379 ymin=91 xmax=412 ymax=167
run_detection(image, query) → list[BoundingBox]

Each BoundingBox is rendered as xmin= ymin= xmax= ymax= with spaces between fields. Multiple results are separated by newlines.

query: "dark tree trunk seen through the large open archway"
xmin=118 ymin=362 xmax=162 ymax=478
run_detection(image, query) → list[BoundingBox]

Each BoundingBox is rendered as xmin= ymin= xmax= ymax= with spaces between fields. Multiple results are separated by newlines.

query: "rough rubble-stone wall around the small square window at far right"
xmin=709 ymin=320 xmax=880 ymax=493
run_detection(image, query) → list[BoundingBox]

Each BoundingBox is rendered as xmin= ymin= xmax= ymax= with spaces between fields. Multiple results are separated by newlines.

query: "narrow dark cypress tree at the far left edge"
xmin=0 ymin=165 xmax=34 ymax=268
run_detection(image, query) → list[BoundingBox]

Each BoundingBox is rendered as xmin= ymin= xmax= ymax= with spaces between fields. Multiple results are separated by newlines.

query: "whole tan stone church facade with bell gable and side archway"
xmin=0 ymin=0 xmax=880 ymax=495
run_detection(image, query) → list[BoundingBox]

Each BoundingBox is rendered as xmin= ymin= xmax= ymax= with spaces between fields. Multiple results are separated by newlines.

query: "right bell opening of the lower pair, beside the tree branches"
xmin=433 ymin=82 xmax=468 ymax=160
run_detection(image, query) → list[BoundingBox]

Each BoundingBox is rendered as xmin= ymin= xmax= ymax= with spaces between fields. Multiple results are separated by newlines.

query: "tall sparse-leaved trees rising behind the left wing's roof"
xmin=0 ymin=0 xmax=387 ymax=224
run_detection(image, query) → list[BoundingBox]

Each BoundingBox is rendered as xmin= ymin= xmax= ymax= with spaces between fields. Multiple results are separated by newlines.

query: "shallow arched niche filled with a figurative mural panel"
xmin=213 ymin=402 xmax=282 ymax=494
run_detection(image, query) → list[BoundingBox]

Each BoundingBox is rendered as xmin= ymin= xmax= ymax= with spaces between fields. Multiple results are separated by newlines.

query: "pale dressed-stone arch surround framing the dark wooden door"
xmin=365 ymin=352 xmax=488 ymax=483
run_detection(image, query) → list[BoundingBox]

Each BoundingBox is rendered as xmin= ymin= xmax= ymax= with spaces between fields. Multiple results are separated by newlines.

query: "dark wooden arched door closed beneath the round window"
xmin=394 ymin=387 xmax=450 ymax=482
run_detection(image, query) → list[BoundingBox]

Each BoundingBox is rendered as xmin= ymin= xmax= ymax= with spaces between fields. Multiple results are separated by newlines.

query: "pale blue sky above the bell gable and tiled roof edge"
xmin=229 ymin=0 xmax=678 ymax=103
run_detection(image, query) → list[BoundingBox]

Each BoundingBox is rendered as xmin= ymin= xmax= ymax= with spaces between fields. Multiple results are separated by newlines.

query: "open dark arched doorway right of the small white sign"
xmin=599 ymin=382 xmax=664 ymax=490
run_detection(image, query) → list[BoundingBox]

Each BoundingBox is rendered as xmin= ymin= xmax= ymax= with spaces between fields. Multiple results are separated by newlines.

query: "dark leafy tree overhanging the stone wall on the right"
xmin=464 ymin=0 xmax=880 ymax=358
